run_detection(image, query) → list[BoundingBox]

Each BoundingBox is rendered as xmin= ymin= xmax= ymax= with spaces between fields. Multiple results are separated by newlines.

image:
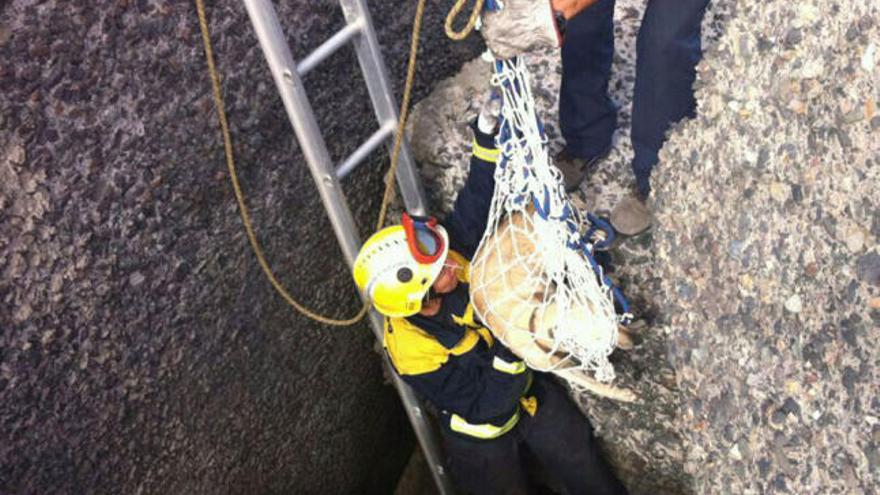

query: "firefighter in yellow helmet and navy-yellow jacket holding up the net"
xmin=354 ymin=112 xmax=626 ymax=495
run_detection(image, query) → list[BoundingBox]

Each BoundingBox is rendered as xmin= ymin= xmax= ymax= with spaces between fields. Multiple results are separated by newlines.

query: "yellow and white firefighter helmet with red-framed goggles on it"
xmin=353 ymin=213 xmax=449 ymax=317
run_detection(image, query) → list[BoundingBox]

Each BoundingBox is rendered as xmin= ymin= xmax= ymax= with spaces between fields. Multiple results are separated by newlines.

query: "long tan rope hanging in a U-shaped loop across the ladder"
xmin=195 ymin=0 xmax=425 ymax=326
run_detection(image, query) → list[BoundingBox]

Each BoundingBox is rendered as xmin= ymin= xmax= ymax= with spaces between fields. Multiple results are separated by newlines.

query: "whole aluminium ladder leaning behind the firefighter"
xmin=243 ymin=0 xmax=455 ymax=495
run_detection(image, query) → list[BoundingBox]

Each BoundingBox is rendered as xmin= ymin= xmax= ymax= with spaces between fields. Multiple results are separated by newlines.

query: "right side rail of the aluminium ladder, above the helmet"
xmin=339 ymin=0 xmax=427 ymax=215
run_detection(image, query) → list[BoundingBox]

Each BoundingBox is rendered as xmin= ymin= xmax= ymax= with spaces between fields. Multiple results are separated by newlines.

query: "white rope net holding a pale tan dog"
xmin=470 ymin=57 xmax=620 ymax=381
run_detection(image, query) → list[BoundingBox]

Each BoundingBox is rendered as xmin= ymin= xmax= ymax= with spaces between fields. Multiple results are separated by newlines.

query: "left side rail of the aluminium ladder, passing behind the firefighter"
xmin=243 ymin=0 xmax=455 ymax=495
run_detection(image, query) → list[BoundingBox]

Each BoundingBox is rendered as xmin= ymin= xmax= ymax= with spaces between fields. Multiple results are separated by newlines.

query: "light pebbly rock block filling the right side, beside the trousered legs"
xmin=654 ymin=1 xmax=880 ymax=494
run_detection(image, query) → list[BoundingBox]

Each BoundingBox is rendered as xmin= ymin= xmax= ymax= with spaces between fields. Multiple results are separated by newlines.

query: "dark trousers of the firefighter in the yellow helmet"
xmin=443 ymin=373 xmax=627 ymax=495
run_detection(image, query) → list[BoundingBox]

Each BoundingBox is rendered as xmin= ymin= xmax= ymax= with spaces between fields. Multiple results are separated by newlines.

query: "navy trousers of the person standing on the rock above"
xmin=559 ymin=0 xmax=709 ymax=195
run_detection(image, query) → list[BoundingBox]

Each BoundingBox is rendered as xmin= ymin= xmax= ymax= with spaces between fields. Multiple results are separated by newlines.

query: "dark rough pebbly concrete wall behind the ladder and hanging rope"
xmin=0 ymin=0 xmax=478 ymax=494
